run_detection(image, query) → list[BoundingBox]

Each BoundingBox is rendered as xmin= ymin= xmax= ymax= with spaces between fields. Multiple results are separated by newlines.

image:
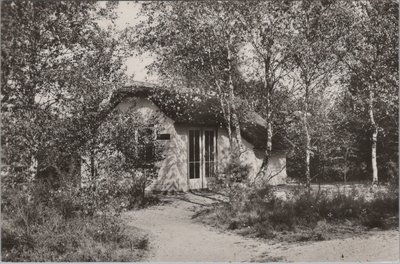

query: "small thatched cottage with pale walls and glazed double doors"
xmin=81 ymin=82 xmax=286 ymax=191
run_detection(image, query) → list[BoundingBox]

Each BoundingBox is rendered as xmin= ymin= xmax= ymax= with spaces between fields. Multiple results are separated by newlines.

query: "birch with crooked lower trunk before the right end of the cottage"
xmin=235 ymin=1 xmax=293 ymax=163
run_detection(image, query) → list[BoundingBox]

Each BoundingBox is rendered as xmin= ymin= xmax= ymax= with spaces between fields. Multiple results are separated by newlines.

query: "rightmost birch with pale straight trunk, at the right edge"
xmin=343 ymin=0 xmax=399 ymax=183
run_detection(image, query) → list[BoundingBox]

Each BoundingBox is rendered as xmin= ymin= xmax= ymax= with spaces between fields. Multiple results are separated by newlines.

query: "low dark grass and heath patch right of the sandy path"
xmin=195 ymin=186 xmax=399 ymax=242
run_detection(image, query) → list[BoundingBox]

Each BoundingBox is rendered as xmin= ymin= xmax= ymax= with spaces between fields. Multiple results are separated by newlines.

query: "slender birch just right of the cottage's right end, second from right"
xmin=290 ymin=1 xmax=348 ymax=190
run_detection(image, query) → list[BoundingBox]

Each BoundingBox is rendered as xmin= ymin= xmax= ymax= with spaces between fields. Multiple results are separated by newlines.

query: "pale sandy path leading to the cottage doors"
xmin=123 ymin=193 xmax=399 ymax=262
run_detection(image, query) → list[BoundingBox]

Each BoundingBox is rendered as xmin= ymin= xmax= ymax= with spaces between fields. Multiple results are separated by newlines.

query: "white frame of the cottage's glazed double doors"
xmin=186 ymin=126 xmax=218 ymax=190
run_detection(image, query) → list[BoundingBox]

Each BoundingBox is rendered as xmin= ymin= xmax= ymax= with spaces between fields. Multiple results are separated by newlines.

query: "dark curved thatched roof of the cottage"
xmin=111 ymin=82 xmax=283 ymax=150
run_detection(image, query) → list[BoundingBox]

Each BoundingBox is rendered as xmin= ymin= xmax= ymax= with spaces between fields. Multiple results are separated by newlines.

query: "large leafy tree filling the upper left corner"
xmin=1 ymin=1 xmax=127 ymax=186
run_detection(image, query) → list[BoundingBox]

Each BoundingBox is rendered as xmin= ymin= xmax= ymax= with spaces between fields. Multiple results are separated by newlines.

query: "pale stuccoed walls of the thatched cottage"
xmin=81 ymin=98 xmax=286 ymax=191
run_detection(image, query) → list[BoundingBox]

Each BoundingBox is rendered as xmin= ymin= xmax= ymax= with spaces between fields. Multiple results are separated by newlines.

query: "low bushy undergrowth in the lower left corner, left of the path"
xmin=1 ymin=186 xmax=148 ymax=262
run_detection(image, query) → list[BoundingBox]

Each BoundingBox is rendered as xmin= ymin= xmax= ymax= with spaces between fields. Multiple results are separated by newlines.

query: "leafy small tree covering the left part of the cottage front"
xmin=82 ymin=106 xmax=164 ymax=208
